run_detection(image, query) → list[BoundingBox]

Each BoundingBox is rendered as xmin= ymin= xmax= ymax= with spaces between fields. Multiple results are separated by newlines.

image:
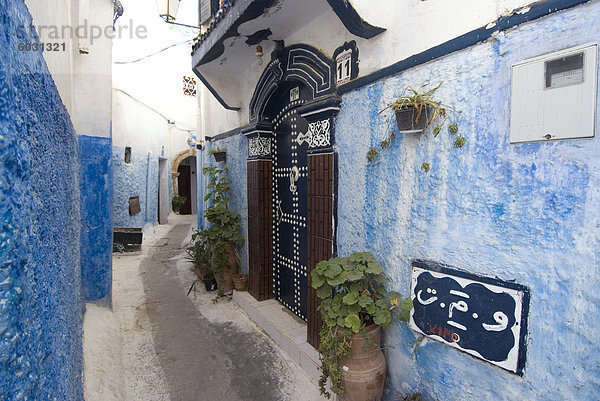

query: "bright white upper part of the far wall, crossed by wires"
xmin=113 ymin=0 xmax=200 ymax=159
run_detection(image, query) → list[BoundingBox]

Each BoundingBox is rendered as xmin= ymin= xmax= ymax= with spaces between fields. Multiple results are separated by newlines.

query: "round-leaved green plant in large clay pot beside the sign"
xmin=311 ymin=252 xmax=412 ymax=400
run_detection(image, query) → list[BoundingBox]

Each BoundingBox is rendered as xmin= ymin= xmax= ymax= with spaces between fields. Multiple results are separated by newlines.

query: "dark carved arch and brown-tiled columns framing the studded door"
xmin=242 ymin=44 xmax=341 ymax=347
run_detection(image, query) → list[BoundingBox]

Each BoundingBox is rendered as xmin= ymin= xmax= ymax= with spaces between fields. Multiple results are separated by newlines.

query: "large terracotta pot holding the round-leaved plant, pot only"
xmin=338 ymin=324 xmax=386 ymax=401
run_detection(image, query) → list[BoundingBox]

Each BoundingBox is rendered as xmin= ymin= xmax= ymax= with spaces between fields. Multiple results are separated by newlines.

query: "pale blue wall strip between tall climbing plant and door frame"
xmin=203 ymin=135 xmax=248 ymax=273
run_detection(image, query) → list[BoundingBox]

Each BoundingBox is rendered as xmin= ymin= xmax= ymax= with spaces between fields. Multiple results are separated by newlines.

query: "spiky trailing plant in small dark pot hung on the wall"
xmin=367 ymin=82 xmax=467 ymax=172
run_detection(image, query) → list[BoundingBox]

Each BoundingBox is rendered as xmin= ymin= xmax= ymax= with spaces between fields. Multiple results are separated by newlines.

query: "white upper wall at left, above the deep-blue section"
xmin=26 ymin=0 xmax=113 ymax=138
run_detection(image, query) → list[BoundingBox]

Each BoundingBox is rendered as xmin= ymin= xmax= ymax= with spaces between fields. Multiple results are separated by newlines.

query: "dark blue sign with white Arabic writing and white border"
xmin=411 ymin=265 xmax=528 ymax=374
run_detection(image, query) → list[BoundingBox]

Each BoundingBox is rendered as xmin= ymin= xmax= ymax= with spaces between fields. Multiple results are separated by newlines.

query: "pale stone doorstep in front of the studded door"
xmin=233 ymin=291 xmax=320 ymax=385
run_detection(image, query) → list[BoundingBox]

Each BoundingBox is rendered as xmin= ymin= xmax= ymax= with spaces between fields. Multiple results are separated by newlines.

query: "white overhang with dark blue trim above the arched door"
xmin=192 ymin=0 xmax=385 ymax=110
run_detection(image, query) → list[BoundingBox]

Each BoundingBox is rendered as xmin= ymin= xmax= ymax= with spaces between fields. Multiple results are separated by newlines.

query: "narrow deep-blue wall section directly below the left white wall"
xmin=78 ymin=135 xmax=112 ymax=303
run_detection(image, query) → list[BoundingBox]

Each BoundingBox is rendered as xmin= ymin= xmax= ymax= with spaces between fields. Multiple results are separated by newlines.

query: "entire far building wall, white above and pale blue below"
xmin=112 ymin=0 xmax=200 ymax=227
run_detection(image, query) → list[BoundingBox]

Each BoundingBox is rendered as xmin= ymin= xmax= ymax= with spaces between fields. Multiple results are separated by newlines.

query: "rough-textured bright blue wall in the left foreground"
xmin=0 ymin=0 xmax=84 ymax=401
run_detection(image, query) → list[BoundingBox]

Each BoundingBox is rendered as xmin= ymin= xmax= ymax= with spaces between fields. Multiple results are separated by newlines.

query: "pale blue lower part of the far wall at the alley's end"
xmin=112 ymin=146 xmax=158 ymax=228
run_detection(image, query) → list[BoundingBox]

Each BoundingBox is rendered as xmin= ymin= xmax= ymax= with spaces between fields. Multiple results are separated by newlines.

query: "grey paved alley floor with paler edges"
xmin=84 ymin=216 xmax=322 ymax=401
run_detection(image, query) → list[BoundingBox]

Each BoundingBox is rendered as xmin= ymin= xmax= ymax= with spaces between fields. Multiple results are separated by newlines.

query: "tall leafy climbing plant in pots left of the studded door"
xmin=201 ymin=167 xmax=244 ymax=293
